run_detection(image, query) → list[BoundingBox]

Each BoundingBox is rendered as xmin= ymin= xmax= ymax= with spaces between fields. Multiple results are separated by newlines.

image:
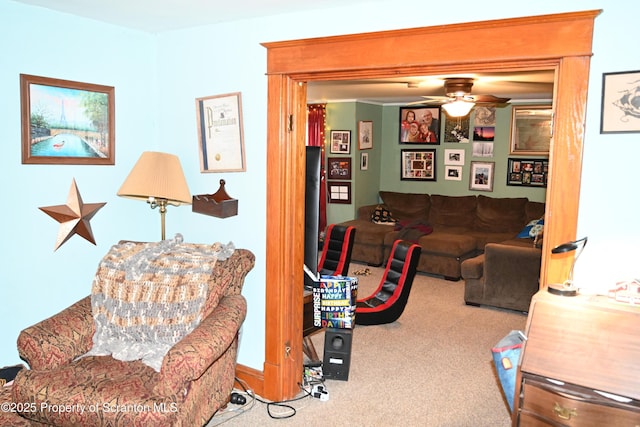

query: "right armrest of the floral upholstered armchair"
xmin=154 ymin=295 xmax=247 ymax=396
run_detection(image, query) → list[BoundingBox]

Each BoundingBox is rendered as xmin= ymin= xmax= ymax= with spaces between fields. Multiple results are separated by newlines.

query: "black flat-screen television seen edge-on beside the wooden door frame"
xmin=303 ymin=146 xmax=322 ymax=289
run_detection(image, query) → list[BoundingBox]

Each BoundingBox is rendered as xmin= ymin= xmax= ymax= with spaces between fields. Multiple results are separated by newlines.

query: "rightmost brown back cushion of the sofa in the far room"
xmin=474 ymin=195 xmax=528 ymax=233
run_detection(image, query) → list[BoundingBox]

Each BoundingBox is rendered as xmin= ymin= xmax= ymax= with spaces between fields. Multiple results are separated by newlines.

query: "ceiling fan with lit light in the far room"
xmin=408 ymin=77 xmax=510 ymax=117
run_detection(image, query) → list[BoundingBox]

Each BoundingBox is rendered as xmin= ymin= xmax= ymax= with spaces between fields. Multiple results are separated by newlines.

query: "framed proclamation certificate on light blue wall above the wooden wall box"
xmin=196 ymin=92 xmax=246 ymax=173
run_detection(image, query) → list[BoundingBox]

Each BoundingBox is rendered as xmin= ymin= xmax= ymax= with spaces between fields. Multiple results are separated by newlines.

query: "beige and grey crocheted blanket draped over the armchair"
xmin=82 ymin=235 xmax=234 ymax=372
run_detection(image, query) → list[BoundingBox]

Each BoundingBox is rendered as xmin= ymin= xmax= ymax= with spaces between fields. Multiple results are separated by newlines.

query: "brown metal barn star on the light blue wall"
xmin=38 ymin=179 xmax=106 ymax=251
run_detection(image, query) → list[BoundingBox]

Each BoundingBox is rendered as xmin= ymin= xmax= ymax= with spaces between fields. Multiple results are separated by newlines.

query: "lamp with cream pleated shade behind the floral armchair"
xmin=118 ymin=151 xmax=191 ymax=240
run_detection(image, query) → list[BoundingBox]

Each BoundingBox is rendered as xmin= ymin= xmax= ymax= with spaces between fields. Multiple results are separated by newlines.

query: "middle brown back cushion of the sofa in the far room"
xmin=429 ymin=195 xmax=478 ymax=229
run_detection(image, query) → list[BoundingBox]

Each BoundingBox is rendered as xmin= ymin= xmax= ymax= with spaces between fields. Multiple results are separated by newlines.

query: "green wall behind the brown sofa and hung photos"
xmin=326 ymin=102 xmax=546 ymax=224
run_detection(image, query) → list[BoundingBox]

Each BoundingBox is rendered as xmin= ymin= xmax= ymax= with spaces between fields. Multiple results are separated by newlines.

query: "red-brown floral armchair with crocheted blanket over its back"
xmin=12 ymin=239 xmax=255 ymax=427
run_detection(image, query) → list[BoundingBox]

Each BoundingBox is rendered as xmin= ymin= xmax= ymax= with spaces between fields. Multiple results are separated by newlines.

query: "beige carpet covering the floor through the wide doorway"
xmin=208 ymin=264 xmax=526 ymax=427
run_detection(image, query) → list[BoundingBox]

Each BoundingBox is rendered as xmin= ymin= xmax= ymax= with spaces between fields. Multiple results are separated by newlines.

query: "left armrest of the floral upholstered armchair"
xmin=18 ymin=296 xmax=95 ymax=370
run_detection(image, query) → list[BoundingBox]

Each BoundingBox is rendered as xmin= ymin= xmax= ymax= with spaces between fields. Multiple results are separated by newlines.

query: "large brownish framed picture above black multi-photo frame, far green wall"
xmin=509 ymin=105 xmax=553 ymax=156
